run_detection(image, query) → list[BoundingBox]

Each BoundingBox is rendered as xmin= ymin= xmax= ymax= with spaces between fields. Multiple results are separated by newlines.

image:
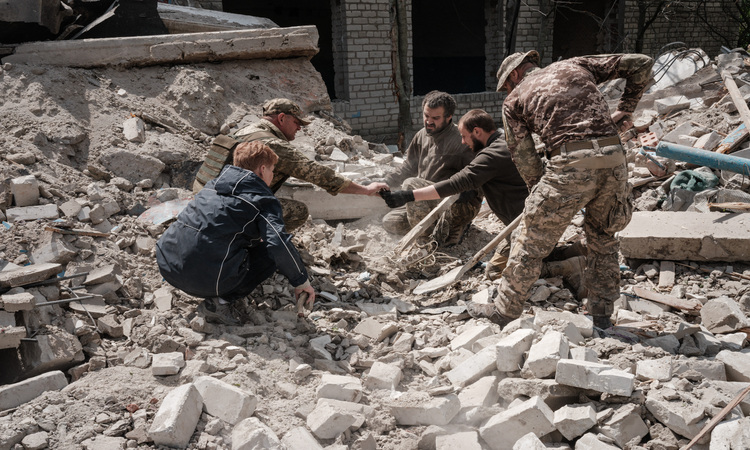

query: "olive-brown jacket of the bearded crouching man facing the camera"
xmin=385 ymin=123 xmax=474 ymax=189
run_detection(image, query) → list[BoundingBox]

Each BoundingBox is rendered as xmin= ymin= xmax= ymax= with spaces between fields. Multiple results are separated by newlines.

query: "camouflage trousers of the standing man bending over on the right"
xmin=494 ymin=145 xmax=632 ymax=317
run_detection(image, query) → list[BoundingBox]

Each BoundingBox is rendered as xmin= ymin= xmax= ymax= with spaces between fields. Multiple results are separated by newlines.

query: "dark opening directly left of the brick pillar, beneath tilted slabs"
xmin=223 ymin=0 xmax=336 ymax=99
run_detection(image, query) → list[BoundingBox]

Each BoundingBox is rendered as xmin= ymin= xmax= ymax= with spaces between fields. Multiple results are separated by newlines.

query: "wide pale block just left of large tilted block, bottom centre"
xmin=390 ymin=391 xmax=461 ymax=425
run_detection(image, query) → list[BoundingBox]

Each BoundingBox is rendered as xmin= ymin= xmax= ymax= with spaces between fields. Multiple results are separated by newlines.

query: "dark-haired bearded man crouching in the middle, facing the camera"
xmin=383 ymin=91 xmax=481 ymax=245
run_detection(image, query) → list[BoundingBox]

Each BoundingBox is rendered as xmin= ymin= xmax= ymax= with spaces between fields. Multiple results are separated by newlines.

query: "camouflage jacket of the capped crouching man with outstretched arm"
xmin=231 ymin=119 xmax=352 ymax=195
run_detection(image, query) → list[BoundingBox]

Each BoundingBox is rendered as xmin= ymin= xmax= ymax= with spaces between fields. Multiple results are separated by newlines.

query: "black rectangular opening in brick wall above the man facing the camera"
xmin=412 ymin=0 xmax=486 ymax=95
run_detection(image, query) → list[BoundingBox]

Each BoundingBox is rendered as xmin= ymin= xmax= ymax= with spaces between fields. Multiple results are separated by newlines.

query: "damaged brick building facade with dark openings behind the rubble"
xmin=170 ymin=0 xmax=739 ymax=140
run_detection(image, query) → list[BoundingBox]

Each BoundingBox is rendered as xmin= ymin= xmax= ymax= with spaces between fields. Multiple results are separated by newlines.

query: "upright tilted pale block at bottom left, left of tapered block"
xmin=148 ymin=384 xmax=203 ymax=448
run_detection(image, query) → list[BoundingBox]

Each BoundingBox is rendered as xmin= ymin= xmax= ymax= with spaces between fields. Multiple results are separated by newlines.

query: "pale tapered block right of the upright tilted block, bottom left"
xmin=193 ymin=377 xmax=258 ymax=425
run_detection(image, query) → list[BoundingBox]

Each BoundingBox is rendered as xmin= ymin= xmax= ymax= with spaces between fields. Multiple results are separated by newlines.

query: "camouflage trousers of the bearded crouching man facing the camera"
xmin=383 ymin=178 xmax=481 ymax=243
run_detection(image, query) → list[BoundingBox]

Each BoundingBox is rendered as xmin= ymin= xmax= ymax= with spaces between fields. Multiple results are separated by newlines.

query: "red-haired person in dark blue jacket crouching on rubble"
xmin=156 ymin=141 xmax=315 ymax=325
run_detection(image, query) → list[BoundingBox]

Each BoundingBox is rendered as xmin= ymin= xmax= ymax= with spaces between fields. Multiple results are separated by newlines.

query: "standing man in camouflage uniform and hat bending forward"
xmin=467 ymin=50 xmax=653 ymax=328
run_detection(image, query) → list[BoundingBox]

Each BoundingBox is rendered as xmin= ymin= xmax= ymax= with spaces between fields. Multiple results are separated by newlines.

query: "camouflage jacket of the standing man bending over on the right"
xmin=503 ymin=54 xmax=654 ymax=186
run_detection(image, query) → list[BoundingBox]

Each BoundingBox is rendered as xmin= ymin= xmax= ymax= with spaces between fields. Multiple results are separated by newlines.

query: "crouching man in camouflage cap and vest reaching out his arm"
xmin=193 ymin=98 xmax=388 ymax=231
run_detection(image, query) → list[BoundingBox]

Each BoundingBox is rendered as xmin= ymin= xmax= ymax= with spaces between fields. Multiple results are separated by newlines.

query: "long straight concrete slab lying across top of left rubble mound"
xmin=2 ymin=26 xmax=322 ymax=68
